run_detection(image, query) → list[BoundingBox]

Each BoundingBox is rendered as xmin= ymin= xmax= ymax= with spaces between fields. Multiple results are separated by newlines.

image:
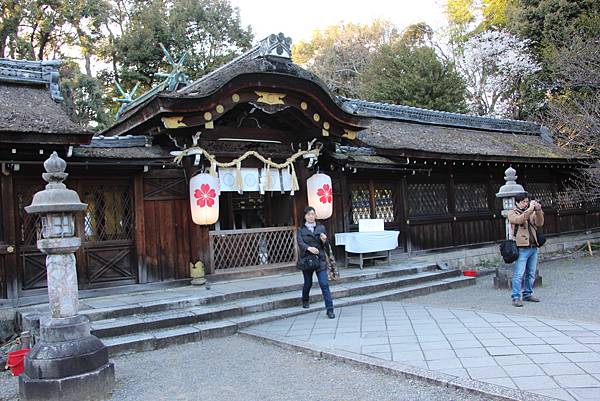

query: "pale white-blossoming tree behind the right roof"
xmin=455 ymin=30 xmax=540 ymax=118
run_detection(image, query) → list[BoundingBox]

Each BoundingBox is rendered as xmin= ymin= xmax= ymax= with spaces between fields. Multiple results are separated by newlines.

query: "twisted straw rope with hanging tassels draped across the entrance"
xmin=171 ymin=146 xmax=321 ymax=195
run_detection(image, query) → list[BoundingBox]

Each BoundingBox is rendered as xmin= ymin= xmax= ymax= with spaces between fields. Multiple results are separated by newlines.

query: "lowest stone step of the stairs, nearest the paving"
xmin=102 ymin=276 xmax=475 ymax=356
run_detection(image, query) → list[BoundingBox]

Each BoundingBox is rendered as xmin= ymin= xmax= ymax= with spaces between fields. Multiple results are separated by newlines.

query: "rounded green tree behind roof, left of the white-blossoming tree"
xmin=361 ymin=40 xmax=467 ymax=112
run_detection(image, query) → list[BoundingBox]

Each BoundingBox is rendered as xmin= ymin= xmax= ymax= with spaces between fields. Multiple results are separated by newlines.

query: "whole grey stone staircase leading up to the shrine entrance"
xmin=18 ymin=264 xmax=474 ymax=355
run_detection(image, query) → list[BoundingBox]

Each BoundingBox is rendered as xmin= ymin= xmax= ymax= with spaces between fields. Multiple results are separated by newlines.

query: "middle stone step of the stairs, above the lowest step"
xmin=91 ymin=270 xmax=460 ymax=338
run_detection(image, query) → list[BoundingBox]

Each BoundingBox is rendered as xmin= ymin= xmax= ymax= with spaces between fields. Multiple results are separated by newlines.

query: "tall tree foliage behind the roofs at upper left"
xmin=0 ymin=0 xmax=252 ymax=128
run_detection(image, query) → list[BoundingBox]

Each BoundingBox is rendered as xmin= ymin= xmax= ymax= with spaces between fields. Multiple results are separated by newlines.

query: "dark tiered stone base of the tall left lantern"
xmin=19 ymin=315 xmax=115 ymax=401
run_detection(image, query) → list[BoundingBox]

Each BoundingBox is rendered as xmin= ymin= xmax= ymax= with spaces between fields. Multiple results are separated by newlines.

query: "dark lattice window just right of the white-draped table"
xmin=408 ymin=184 xmax=448 ymax=216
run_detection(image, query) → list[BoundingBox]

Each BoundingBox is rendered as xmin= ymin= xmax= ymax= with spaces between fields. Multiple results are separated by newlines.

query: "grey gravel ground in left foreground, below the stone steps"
xmin=0 ymin=335 xmax=486 ymax=401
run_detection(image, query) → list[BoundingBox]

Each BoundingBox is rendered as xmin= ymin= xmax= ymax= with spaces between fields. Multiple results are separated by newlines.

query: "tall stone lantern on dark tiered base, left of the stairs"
xmin=19 ymin=152 xmax=114 ymax=400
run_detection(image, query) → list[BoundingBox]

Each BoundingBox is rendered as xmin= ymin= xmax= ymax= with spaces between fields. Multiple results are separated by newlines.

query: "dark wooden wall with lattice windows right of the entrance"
xmin=332 ymin=166 xmax=600 ymax=252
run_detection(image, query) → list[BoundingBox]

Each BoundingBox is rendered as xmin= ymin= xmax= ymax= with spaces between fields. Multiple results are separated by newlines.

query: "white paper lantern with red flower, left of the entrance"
xmin=190 ymin=173 xmax=219 ymax=225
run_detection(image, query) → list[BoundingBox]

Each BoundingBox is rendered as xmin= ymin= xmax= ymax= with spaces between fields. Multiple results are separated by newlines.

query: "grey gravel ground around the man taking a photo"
xmin=402 ymin=256 xmax=600 ymax=322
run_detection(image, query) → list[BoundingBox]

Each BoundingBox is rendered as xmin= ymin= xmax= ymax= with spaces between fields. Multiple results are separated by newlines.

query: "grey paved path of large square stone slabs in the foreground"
xmin=253 ymin=302 xmax=600 ymax=401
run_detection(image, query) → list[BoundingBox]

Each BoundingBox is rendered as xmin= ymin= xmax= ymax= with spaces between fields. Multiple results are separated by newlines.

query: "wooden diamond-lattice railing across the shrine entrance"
xmin=209 ymin=227 xmax=298 ymax=273
